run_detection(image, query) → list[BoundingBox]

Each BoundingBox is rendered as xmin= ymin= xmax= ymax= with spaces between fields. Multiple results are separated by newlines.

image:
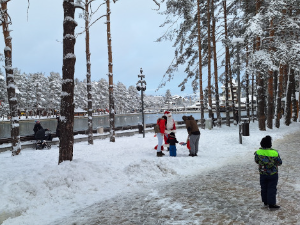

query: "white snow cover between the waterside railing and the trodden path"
xmin=0 ymin=121 xmax=300 ymax=225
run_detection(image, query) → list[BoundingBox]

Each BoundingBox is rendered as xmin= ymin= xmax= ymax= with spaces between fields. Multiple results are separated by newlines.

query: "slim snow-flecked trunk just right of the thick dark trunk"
xmin=85 ymin=0 xmax=94 ymax=145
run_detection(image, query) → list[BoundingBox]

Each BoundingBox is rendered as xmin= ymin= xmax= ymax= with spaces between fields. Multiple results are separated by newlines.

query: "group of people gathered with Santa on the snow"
xmin=155 ymin=111 xmax=200 ymax=157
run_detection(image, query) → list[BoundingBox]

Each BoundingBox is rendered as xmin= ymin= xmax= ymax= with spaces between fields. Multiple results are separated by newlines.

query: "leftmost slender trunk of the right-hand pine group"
xmin=197 ymin=0 xmax=205 ymax=129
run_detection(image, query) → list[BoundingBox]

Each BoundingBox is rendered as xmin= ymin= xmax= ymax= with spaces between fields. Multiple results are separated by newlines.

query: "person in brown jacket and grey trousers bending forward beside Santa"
xmin=182 ymin=116 xmax=200 ymax=157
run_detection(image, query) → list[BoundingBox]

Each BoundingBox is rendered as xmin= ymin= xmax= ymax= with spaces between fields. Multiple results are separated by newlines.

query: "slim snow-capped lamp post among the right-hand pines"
xmin=232 ymin=38 xmax=244 ymax=144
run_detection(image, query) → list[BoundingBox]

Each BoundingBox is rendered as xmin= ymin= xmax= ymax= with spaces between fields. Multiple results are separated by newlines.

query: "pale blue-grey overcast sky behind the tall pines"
xmin=0 ymin=0 xmax=198 ymax=95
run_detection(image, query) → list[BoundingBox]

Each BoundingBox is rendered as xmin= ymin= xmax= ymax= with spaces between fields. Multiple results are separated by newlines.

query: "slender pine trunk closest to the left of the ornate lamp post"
xmin=106 ymin=0 xmax=115 ymax=142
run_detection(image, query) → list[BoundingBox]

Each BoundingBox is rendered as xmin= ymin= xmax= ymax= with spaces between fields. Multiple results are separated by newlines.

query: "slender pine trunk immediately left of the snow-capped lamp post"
xmin=223 ymin=0 xmax=230 ymax=126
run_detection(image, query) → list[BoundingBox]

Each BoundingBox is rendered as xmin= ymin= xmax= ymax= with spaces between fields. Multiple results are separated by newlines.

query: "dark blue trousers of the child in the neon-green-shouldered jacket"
xmin=260 ymin=174 xmax=278 ymax=205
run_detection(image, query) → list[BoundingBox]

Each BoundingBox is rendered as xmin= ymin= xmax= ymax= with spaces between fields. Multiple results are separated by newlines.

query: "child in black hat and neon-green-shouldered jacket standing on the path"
xmin=254 ymin=136 xmax=282 ymax=210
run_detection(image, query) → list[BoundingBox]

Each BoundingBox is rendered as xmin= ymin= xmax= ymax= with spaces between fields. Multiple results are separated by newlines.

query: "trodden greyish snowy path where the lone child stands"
xmin=55 ymin=132 xmax=300 ymax=225
